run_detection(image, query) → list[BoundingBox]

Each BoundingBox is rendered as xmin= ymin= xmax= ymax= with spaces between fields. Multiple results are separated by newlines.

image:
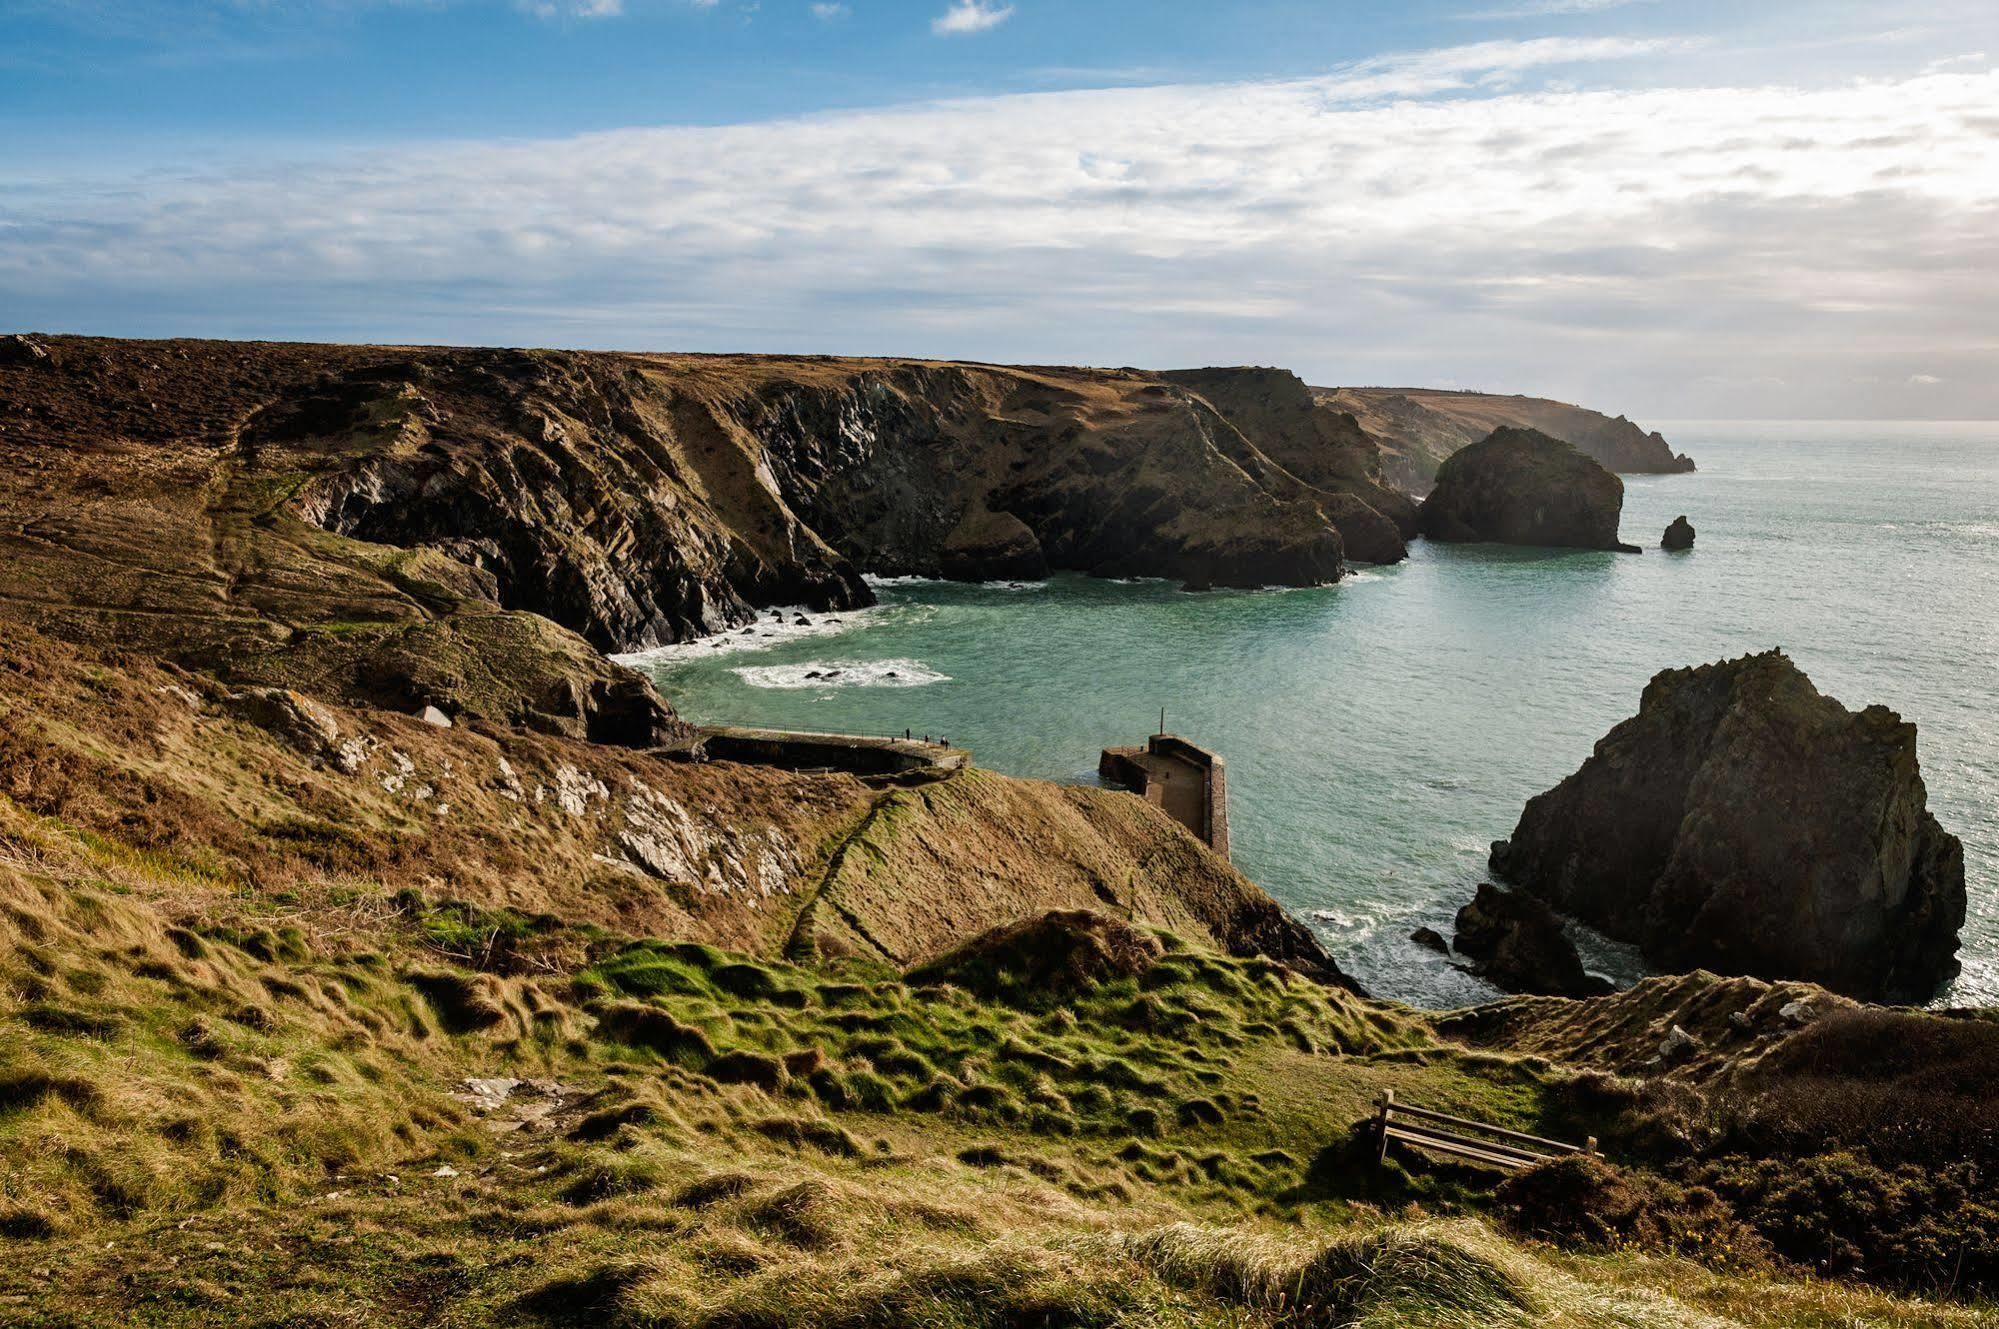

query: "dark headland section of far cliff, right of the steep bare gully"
xmin=735 ymin=362 xmax=1345 ymax=586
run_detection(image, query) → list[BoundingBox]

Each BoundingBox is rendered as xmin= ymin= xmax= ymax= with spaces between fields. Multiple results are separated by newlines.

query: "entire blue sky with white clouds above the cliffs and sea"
xmin=0 ymin=0 xmax=1999 ymax=420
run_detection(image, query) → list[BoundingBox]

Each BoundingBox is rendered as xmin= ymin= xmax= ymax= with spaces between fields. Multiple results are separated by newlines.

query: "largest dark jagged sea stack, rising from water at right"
xmin=1491 ymin=652 xmax=1965 ymax=999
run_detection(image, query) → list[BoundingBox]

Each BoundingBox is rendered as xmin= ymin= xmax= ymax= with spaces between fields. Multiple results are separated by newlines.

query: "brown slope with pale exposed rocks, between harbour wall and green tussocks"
xmin=0 ymin=602 xmax=1335 ymax=977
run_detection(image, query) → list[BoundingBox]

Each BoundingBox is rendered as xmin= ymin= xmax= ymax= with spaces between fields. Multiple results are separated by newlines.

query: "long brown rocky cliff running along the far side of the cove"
xmin=0 ymin=338 xmax=1413 ymax=683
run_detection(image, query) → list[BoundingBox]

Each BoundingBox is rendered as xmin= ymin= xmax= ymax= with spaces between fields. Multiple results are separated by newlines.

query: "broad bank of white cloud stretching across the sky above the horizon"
xmin=0 ymin=42 xmax=1999 ymax=418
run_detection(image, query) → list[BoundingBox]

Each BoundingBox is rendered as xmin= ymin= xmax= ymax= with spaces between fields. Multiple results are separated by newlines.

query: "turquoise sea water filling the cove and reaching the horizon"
xmin=631 ymin=422 xmax=1999 ymax=1003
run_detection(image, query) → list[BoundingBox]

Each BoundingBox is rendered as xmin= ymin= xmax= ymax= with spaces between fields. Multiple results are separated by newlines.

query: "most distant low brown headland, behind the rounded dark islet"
xmin=1311 ymin=388 xmax=1693 ymax=494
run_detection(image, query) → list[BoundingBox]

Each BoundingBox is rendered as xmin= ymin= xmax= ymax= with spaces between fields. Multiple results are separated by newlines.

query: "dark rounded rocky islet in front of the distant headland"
xmin=1417 ymin=428 xmax=1631 ymax=552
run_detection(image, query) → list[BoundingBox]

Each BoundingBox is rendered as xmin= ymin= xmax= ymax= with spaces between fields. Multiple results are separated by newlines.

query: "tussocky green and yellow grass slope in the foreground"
xmin=0 ymin=763 xmax=1979 ymax=1325
